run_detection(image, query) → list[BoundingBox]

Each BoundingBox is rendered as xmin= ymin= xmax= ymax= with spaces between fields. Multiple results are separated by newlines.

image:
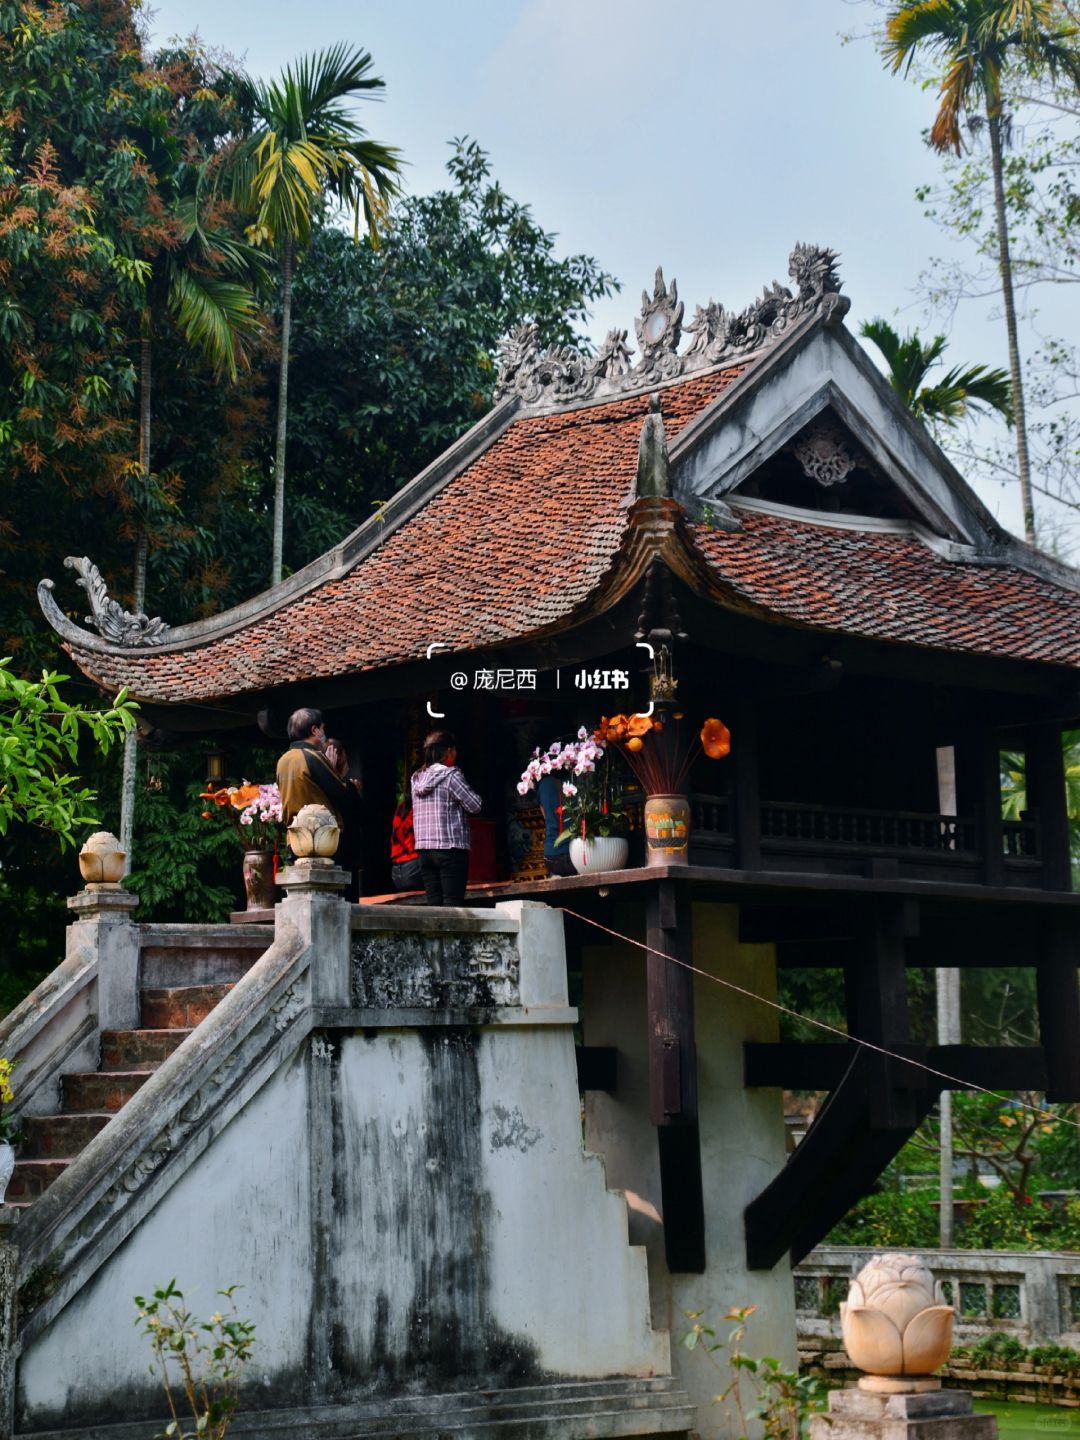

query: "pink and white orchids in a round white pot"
xmin=517 ymin=726 xmax=629 ymax=874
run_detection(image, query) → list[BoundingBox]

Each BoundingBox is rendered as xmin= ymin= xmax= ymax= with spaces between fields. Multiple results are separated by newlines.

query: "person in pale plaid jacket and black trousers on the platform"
xmin=412 ymin=730 xmax=482 ymax=904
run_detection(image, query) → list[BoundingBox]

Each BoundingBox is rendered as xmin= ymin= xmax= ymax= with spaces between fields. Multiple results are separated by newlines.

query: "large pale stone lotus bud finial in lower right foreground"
xmin=840 ymin=1256 xmax=953 ymax=1388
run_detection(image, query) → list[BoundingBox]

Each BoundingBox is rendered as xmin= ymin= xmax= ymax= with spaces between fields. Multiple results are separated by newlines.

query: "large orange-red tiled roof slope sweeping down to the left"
xmin=63 ymin=366 xmax=744 ymax=704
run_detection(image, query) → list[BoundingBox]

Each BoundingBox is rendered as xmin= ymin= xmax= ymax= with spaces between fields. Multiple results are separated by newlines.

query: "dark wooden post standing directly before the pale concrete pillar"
xmin=645 ymin=880 xmax=706 ymax=1274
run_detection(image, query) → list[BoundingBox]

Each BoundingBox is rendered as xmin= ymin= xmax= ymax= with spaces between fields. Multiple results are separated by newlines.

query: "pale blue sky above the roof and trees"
xmin=139 ymin=0 xmax=1059 ymax=541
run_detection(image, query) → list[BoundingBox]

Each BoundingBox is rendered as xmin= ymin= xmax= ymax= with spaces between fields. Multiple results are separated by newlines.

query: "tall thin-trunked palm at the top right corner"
xmin=883 ymin=0 xmax=1080 ymax=543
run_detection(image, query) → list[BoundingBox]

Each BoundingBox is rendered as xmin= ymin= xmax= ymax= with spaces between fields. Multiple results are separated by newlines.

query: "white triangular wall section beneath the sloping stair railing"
xmin=16 ymin=1054 xmax=312 ymax=1431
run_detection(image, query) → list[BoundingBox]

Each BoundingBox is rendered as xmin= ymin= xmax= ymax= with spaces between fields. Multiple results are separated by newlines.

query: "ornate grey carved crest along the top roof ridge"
xmin=495 ymin=243 xmax=851 ymax=406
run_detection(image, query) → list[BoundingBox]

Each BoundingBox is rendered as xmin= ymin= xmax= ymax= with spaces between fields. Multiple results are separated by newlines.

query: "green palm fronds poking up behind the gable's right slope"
xmin=860 ymin=318 xmax=1012 ymax=425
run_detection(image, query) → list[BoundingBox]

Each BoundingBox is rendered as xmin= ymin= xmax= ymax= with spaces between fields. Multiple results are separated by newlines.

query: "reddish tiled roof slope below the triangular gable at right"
xmin=691 ymin=511 xmax=1080 ymax=665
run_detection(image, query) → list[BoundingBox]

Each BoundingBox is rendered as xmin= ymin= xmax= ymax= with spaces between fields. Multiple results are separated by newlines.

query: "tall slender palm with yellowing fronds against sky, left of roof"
xmin=230 ymin=45 xmax=400 ymax=585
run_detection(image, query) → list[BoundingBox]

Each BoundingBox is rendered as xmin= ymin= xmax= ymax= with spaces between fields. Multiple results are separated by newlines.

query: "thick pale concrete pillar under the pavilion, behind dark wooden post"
xmin=585 ymin=904 xmax=796 ymax=1440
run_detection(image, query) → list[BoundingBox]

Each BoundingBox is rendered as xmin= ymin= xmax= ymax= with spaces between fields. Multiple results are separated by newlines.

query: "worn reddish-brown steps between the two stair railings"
xmin=4 ymin=926 xmax=272 ymax=1210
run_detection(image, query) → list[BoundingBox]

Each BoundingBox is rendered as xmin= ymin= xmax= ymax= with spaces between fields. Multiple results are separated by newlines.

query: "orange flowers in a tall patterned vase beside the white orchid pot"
xmin=595 ymin=701 xmax=732 ymax=865
